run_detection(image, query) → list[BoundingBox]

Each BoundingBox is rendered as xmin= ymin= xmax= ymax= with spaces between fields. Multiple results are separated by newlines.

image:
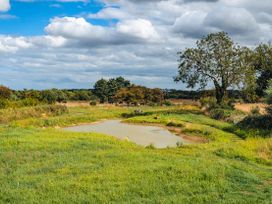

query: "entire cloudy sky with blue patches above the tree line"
xmin=0 ymin=0 xmax=272 ymax=89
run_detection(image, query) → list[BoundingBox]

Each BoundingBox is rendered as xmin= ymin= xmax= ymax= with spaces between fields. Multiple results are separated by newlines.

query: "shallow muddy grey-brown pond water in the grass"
xmin=64 ymin=120 xmax=194 ymax=148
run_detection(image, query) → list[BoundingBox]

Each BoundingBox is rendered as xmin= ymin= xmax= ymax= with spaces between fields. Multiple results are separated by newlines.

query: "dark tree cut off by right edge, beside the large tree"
xmin=253 ymin=43 xmax=272 ymax=96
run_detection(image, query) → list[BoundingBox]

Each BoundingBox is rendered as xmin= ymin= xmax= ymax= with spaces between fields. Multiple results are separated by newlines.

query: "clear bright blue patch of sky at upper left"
xmin=0 ymin=0 xmax=104 ymax=36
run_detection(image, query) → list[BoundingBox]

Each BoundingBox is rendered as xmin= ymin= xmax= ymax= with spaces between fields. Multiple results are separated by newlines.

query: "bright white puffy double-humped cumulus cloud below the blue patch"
xmin=45 ymin=17 xmax=159 ymax=45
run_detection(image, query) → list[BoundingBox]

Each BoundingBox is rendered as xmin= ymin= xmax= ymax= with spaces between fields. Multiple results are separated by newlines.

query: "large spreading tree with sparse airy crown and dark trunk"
xmin=175 ymin=32 xmax=249 ymax=104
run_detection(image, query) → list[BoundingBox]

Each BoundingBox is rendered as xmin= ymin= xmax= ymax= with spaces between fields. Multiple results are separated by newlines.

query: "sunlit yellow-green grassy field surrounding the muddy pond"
xmin=0 ymin=105 xmax=272 ymax=204
